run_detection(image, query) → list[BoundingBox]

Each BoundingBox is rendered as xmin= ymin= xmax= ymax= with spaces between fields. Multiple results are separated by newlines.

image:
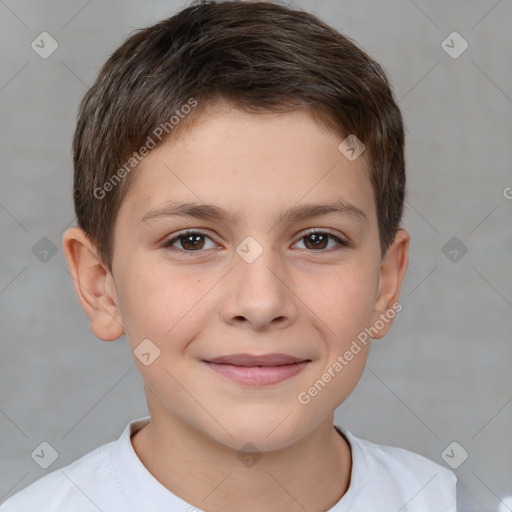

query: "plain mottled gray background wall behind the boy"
xmin=0 ymin=0 xmax=512 ymax=511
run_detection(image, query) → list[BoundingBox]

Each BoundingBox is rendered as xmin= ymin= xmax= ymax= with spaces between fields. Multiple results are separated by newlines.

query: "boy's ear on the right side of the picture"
xmin=372 ymin=229 xmax=410 ymax=339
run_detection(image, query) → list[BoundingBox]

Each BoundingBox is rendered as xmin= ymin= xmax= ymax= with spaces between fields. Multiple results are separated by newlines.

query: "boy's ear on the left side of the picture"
xmin=62 ymin=227 xmax=124 ymax=341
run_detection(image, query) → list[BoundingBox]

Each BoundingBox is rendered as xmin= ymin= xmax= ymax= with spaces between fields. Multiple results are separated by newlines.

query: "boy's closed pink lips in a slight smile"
xmin=203 ymin=354 xmax=311 ymax=386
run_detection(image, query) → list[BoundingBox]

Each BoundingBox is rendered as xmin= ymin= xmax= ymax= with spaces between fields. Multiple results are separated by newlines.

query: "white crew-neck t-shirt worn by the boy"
xmin=0 ymin=417 xmax=457 ymax=512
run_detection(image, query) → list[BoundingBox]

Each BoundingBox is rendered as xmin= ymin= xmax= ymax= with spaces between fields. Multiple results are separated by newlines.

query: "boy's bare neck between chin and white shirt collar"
xmin=132 ymin=402 xmax=352 ymax=512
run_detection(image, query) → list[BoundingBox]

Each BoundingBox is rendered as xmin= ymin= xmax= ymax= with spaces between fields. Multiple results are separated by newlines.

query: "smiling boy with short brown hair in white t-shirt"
xmin=0 ymin=2 xmax=464 ymax=512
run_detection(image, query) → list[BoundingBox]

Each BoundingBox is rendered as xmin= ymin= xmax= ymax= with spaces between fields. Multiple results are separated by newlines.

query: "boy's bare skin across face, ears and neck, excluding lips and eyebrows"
xmin=63 ymin=104 xmax=409 ymax=512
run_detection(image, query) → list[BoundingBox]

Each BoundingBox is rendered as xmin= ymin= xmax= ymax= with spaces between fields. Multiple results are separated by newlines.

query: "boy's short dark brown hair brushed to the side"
xmin=73 ymin=0 xmax=405 ymax=270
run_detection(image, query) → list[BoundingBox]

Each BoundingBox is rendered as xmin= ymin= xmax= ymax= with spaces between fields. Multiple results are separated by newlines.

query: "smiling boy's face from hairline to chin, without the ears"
xmin=106 ymin=106 xmax=398 ymax=451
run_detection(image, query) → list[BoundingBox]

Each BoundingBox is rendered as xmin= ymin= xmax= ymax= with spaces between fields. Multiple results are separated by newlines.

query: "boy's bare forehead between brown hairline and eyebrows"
xmin=120 ymin=105 xmax=375 ymax=228
